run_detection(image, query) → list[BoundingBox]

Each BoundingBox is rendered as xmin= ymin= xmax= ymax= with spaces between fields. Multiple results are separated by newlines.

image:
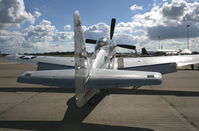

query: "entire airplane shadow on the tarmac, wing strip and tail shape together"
xmin=0 ymin=87 xmax=199 ymax=131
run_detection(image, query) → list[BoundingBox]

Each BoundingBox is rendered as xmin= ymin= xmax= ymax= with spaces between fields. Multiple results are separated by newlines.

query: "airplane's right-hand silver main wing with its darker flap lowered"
xmin=118 ymin=55 xmax=199 ymax=74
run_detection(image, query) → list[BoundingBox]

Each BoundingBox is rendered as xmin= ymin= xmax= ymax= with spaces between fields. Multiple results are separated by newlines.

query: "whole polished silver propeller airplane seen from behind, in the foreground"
xmin=6 ymin=11 xmax=199 ymax=107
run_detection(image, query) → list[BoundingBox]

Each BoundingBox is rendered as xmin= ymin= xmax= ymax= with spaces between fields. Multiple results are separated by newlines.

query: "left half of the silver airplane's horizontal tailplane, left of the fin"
xmin=17 ymin=69 xmax=75 ymax=88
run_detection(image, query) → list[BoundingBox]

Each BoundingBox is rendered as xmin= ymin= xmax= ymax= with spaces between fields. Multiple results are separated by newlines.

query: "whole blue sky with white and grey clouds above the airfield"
xmin=0 ymin=0 xmax=199 ymax=53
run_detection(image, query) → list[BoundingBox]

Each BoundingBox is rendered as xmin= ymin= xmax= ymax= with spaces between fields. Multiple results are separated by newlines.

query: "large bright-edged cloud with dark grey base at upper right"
xmin=133 ymin=0 xmax=199 ymax=39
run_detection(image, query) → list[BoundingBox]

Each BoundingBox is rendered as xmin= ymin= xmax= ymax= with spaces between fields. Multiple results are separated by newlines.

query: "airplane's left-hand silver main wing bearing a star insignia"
xmin=5 ymin=55 xmax=74 ymax=67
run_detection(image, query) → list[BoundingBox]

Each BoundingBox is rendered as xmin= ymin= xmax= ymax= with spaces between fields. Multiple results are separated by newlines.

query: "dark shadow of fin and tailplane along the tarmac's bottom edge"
xmin=0 ymin=96 xmax=153 ymax=131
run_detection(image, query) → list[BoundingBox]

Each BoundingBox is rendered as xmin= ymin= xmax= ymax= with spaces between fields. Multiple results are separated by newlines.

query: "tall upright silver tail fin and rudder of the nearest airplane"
xmin=74 ymin=11 xmax=97 ymax=107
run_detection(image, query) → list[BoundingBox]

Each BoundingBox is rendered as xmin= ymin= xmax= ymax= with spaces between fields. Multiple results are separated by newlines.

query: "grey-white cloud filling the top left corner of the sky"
xmin=0 ymin=0 xmax=36 ymax=28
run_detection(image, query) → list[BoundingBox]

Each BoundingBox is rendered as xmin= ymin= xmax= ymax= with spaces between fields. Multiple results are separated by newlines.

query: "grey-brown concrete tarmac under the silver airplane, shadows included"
xmin=0 ymin=58 xmax=199 ymax=131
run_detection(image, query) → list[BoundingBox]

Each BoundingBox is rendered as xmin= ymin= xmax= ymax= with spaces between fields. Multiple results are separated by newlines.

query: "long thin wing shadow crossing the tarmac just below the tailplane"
xmin=0 ymin=87 xmax=199 ymax=97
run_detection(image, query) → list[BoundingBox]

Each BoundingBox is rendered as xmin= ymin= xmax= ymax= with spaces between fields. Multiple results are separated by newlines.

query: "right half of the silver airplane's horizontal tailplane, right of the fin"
xmin=87 ymin=69 xmax=162 ymax=88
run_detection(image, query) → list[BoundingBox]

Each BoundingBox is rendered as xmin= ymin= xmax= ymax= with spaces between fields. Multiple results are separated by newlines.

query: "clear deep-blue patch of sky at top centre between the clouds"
xmin=24 ymin=0 xmax=153 ymax=30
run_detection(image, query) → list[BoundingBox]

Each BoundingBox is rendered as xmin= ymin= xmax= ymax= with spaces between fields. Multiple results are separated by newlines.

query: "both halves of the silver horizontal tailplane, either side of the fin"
xmin=17 ymin=69 xmax=162 ymax=88
